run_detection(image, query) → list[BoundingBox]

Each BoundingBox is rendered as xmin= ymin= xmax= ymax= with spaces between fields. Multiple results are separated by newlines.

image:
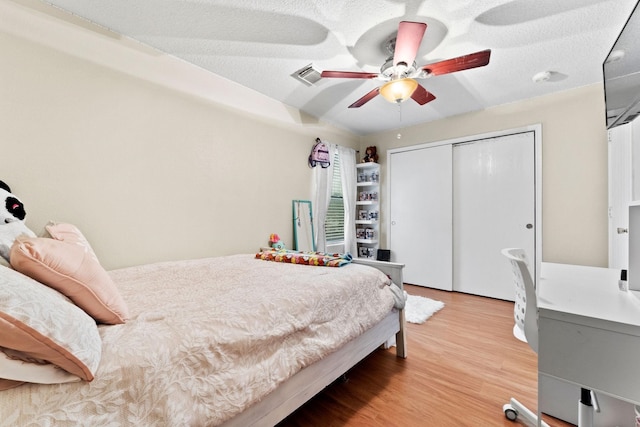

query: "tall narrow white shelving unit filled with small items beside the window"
xmin=356 ymin=162 xmax=380 ymax=259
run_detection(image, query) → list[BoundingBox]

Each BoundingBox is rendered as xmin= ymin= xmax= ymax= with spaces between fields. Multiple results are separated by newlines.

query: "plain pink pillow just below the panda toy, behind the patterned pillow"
xmin=10 ymin=224 xmax=129 ymax=325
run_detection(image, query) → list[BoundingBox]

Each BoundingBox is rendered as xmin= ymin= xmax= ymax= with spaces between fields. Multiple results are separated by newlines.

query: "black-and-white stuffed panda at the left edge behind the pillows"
xmin=0 ymin=181 xmax=36 ymax=261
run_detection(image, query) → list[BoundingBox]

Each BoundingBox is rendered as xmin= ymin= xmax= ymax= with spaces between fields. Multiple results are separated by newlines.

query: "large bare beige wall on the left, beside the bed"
xmin=0 ymin=0 xmax=359 ymax=269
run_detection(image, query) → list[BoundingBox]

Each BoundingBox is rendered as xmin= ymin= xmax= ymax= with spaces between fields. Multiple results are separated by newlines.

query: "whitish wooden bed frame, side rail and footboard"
xmin=223 ymin=258 xmax=407 ymax=427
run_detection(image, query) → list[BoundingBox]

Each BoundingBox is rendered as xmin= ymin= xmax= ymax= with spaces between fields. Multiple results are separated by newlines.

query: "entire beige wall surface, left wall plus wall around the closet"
xmin=0 ymin=0 xmax=607 ymax=268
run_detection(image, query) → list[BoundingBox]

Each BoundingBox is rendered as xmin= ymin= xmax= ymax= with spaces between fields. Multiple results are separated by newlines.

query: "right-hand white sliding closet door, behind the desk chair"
xmin=453 ymin=132 xmax=536 ymax=301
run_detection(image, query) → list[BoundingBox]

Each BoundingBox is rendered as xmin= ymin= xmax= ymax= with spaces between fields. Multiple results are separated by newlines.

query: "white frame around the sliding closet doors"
xmin=384 ymin=123 xmax=542 ymax=285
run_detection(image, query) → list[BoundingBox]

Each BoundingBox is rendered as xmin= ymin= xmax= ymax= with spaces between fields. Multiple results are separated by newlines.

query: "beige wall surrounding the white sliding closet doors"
xmin=360 ymin=84 xmax=608 ymax=266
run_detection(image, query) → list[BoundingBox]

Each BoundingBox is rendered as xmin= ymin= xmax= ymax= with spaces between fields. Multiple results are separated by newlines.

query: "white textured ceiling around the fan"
xmin=40 ymin=0 xmax=637 ymax=135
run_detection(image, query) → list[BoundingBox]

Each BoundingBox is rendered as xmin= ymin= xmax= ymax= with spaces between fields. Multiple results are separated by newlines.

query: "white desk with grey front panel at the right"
xmin=538 ymin=263 xmax=640 ymax=404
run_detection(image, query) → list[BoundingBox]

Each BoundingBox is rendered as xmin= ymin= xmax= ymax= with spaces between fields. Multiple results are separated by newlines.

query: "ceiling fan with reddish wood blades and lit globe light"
xmin=321 ymin=21 xmax=491 ymax=108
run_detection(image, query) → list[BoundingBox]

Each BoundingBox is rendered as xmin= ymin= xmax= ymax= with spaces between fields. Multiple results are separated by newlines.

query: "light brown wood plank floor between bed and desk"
xmin=279 ymin=285 xmax=571 ymax=427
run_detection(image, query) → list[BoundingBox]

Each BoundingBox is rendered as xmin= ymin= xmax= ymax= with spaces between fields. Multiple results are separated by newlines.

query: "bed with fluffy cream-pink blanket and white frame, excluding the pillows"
xmin=0 ymin=234 xmax=406 ymax=426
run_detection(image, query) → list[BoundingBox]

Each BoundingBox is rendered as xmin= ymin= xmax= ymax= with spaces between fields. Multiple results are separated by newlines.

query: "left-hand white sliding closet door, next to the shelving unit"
xmin=389 ymin=145 xmax=453 ymax=291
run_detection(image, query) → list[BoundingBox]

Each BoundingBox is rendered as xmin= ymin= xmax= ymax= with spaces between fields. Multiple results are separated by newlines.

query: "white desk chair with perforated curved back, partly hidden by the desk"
xmin=502 ymin=248 xmax=599 ymax=427
